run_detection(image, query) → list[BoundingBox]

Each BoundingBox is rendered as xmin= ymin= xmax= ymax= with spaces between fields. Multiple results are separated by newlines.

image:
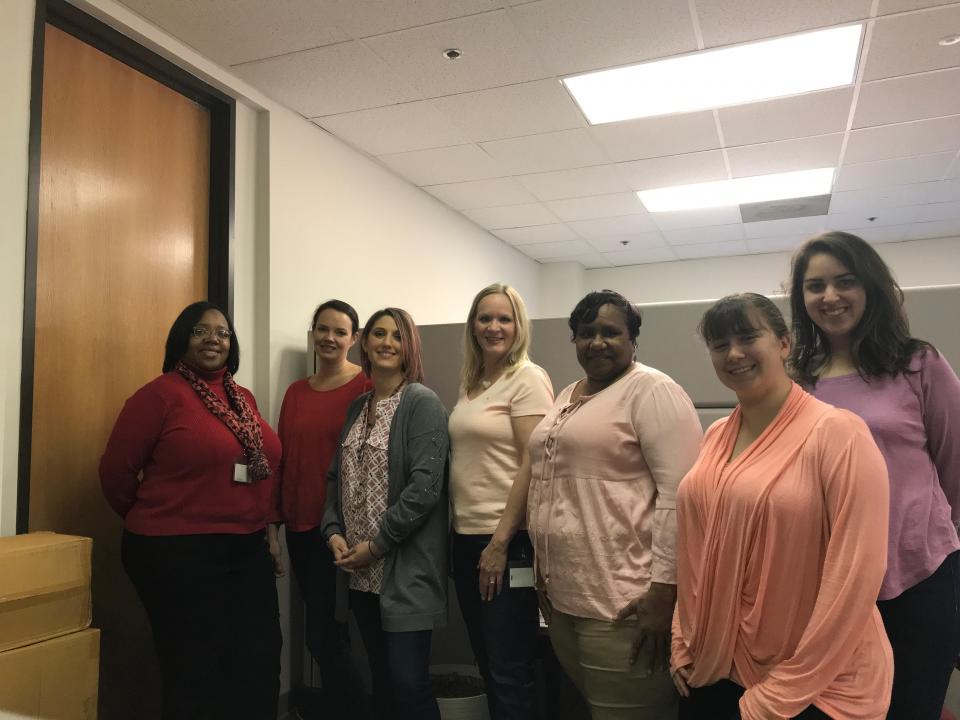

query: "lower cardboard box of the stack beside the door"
xmin=0 ymin=630 xmax=100 ymax=720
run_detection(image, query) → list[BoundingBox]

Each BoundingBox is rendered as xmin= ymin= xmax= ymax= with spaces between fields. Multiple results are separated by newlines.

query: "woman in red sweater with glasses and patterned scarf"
xmin=100 ymin=302 xmax=282 ymax=720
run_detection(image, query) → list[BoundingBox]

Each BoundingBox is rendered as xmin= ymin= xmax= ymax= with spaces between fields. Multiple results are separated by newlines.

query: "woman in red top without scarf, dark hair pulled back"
xmin=277 ymin=300 xmax=373 ymax=720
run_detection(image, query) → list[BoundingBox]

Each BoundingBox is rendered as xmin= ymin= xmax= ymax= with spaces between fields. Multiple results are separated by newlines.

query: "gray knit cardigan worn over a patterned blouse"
xmin=321 ymin=383 xmax=450 ymax=632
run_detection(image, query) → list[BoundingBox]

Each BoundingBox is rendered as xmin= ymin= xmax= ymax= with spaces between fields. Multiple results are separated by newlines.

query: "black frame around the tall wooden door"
xmin=17 ymin=0 xmax=236 ymax=533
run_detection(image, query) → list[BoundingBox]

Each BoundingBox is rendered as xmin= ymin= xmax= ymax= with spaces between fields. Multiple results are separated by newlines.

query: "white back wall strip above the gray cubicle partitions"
xmin=541 ymin=238 xmax=960 ymax=317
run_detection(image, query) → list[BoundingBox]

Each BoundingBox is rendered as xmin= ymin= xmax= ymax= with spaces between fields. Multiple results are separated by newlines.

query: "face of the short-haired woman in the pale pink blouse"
xmin=573 ymin=304 xmax=634 ymax=387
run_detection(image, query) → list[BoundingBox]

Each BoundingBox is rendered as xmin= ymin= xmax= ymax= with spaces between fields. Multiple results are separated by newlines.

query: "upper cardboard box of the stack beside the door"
xmin=0 ymin=533 xmax=93 ymax=652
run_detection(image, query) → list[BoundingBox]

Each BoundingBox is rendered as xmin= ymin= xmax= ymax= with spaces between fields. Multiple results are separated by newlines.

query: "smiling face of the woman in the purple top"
xmin=803 ymin=253 xmax=867 ymax=344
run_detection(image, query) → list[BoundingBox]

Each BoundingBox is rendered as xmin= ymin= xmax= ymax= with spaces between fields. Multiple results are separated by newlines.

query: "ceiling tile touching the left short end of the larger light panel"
xmin=433 ymin=80 xmax=587 ymax=142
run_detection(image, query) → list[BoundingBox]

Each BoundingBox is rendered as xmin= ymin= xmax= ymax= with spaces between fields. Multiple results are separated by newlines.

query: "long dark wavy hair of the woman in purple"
xmin=790 ymin=231 xmax=936 ymax=387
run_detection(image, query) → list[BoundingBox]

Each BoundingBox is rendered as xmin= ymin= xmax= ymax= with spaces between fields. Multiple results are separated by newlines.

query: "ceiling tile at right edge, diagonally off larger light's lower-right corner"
xmin=853 ymin=68 xmax=960 ymax=128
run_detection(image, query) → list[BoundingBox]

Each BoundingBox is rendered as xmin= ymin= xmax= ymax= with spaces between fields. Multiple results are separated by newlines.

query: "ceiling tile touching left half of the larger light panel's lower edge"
xmin=590 ymin=112 xmax=720 ymax=161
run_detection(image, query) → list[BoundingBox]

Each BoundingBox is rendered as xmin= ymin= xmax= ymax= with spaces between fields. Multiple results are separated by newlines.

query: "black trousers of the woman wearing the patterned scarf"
xmin=121 ymin=531 xmax=282 ymax=720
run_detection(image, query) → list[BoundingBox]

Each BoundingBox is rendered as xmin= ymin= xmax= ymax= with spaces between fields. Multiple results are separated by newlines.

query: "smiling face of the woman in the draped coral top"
xmin=707 ymin=310 xmax=790 ymax=402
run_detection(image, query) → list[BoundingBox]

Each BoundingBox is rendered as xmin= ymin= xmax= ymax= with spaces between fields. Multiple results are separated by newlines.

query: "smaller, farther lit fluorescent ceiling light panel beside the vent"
xmin=637 ymin=168 xmax=834 ymax=212
